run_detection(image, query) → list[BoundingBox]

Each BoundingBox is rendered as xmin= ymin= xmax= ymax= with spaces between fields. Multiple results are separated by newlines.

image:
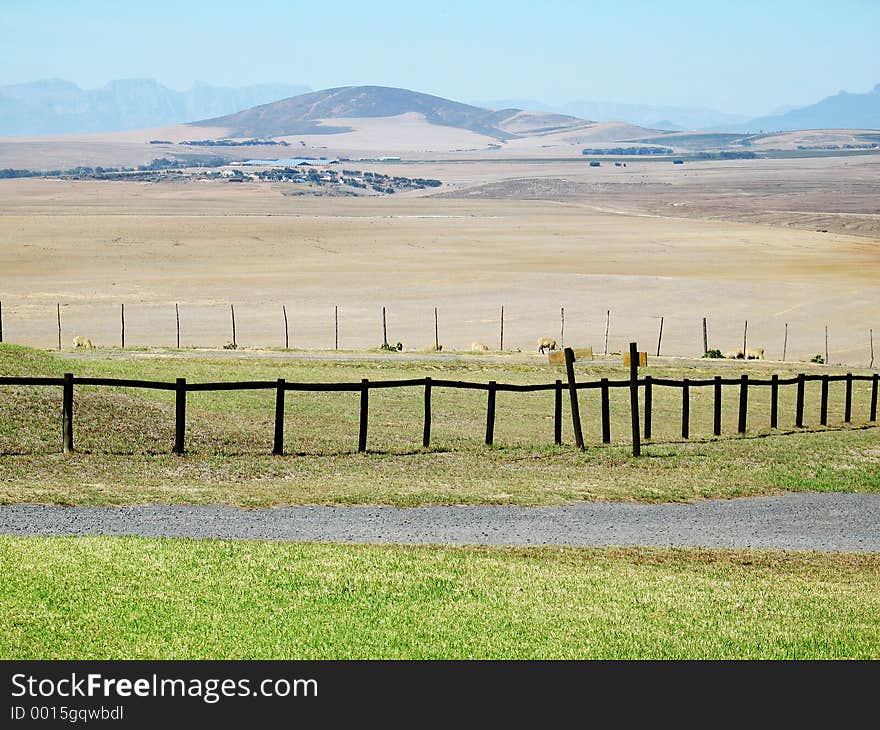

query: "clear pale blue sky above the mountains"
xmin=0 ymin=0 xmax=880 ymax=115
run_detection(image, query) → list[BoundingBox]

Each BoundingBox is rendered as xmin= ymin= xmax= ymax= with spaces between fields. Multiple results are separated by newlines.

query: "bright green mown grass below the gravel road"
xmin=0 ymin=537 xmax=880 ymax=659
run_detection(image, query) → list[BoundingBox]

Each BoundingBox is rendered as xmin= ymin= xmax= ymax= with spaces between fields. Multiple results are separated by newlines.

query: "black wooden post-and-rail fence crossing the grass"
xmin=0 ymin=351 xmax=880 ymax=455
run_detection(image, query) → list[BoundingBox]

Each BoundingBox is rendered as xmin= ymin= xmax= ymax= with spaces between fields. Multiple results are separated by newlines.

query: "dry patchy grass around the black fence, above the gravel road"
xmin=0 ymin=345 xmax=880 ymax=506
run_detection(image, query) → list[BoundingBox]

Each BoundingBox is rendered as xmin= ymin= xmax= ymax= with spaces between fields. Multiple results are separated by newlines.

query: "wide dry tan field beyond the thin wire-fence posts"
xmin=0 ymin=155 xmax=880 ymax=366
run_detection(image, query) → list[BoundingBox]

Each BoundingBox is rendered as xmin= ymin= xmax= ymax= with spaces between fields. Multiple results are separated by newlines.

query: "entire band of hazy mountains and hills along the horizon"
xmin=0 ymin=79 xmax=880 ymax=139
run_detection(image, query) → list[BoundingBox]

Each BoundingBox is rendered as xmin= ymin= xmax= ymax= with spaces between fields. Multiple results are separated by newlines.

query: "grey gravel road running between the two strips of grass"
xmin=0 ymin=493 xmax=880 ymax=552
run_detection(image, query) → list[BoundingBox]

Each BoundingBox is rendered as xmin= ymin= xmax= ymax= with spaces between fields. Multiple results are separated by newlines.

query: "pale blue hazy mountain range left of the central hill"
xmin=0 ymin=79 xmax=310 ymax=136
